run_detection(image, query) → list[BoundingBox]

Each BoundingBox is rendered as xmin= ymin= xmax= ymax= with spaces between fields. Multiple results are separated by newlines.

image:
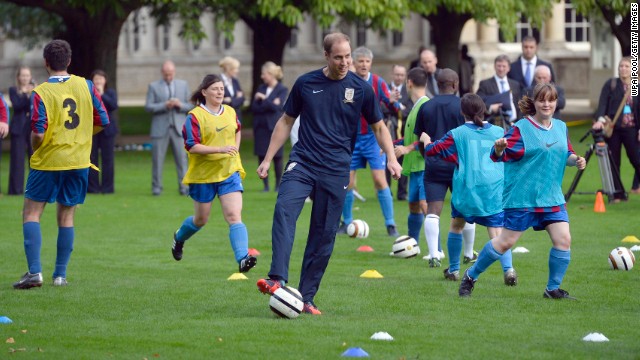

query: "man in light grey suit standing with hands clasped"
xmin=144 ymin=60 xmax=192 ymax=196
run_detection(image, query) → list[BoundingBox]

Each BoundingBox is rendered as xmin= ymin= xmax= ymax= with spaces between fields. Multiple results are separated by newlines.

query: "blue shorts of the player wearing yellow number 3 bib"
xmin=24 ymin=168 xmax=89 ymax=206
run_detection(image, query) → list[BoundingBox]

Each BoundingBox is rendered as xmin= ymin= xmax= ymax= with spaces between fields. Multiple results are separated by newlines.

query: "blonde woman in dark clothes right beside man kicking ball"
xmin=251 ymin=61 xmax=289 ymax=192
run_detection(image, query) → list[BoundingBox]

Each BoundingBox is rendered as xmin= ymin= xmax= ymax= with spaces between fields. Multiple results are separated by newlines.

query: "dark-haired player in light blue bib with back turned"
xmin=420 ymin=94 xmax=518 ymax=286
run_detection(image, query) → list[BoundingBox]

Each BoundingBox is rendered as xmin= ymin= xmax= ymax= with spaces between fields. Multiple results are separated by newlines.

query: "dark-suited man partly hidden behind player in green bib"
xmin=382 ymin=64 xmax=413 ymax=200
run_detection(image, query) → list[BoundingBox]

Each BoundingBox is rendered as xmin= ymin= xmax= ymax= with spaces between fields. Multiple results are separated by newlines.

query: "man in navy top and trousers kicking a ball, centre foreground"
xmin=257 ymin=33 xmax=402 ymax=315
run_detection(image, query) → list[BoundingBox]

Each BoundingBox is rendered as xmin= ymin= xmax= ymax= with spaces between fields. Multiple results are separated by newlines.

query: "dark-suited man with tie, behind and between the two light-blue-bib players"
xmin=476 ymin=55 xmax=522 ymax=126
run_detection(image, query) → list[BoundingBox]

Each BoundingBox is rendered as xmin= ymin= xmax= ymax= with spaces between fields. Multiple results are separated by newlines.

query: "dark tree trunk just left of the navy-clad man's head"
xmin=241 ymin=16 xmax=291 ymax=98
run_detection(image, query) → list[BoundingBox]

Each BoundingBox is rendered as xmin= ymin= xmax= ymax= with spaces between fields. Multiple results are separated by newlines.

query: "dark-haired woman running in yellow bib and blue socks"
xmin=171 ymin=75 xmax=257 ymax=272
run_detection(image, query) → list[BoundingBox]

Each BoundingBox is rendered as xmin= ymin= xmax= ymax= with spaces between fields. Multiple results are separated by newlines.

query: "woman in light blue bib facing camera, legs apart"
xmin=459 ymin=83 xmax=586 ymax=299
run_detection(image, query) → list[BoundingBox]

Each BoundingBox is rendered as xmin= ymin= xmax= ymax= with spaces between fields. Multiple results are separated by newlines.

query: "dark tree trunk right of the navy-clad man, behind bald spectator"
xmin=426 ymin=6 xmax=471 ymax=75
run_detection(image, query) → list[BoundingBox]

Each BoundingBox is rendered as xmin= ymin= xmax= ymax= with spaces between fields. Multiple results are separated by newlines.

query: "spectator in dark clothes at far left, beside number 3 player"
xmin=7 ymin=66 xmax=35 ymax=195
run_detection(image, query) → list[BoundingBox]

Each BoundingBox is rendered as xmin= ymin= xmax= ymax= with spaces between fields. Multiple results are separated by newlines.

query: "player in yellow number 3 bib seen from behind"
xmin=13 ymin=40 xmax=109 ymax=289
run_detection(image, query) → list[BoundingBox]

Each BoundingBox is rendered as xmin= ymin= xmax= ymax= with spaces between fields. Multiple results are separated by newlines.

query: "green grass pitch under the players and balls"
xmin=0 ymin=126 xmax=640 ymax=360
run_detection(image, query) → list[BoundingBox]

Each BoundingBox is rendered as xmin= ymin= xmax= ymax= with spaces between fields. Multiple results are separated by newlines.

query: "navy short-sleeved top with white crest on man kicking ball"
xmin=284 ymin=69 xmax=383 ymax=174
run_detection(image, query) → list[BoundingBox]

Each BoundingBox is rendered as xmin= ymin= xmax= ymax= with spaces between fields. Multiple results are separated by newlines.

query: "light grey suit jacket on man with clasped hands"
xmin=144 ymin=79 xmax=193 ymax=138
